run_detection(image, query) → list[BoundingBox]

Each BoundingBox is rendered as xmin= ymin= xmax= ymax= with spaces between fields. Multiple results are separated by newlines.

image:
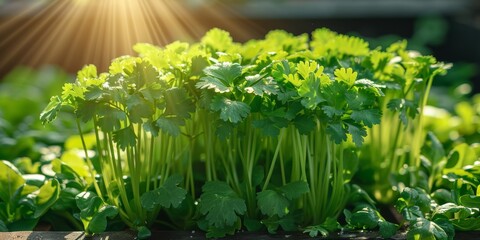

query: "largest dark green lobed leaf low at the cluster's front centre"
xmin=199 ymin=181 xmax=247 ymax=228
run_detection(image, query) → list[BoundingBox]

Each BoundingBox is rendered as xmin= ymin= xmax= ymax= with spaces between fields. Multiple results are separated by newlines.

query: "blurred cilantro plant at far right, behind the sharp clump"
xmin=312 ymin=29 xmax=449 ymax=203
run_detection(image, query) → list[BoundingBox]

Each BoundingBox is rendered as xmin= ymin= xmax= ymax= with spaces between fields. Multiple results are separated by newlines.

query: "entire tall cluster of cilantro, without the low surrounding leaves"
xmin=41 ymin=29 xmax=450 ymax=237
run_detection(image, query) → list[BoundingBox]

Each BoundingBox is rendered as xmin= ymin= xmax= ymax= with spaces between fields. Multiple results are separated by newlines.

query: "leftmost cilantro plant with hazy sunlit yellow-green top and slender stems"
xmin=41 ymin=44 xmax=202 ymax=237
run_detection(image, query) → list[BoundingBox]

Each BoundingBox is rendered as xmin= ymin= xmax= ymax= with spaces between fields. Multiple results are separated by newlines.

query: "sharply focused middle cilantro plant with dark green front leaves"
xmin=196 ymin=30 xmax=382 ymax=237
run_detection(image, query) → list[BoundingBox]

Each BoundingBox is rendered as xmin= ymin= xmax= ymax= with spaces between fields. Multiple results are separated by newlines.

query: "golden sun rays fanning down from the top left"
xmin=0 ymin=0 xmax=258 ymax=75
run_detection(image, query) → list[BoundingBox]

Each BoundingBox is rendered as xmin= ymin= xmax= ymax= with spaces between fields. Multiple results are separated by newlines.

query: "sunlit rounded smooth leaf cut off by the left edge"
xmin=0 ymin=160 xmax=25 ymax=203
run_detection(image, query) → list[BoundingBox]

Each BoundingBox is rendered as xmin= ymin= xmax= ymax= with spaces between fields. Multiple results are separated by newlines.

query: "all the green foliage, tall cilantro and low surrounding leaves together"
xmin=0 ymin=26 xmax=478 ymax=239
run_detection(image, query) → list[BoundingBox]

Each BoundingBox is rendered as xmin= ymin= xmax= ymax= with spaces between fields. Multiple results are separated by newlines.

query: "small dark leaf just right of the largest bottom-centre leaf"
xmin=257 ymin=190 xmax=290 ymax=217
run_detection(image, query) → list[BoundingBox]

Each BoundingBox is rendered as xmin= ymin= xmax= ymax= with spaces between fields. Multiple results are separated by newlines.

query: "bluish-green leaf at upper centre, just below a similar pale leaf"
xmin=210 ymin=96 xmax=250 ymax=123
